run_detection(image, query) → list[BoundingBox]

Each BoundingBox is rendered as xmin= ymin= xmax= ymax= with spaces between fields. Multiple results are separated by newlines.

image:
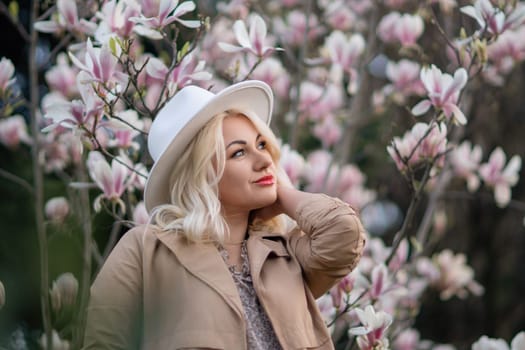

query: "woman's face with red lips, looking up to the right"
xmin=219 ymin=115 xmax=277 ymax=215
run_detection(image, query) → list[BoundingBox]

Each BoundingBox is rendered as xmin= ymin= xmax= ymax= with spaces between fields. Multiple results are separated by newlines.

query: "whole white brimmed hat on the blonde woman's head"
xmin=144 ymin=80 xmax=273 ymax=212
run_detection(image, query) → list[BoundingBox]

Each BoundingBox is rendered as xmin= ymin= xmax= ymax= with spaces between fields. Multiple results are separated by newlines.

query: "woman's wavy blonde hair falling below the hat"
xmin=152 ymin=110 xmax=280 ymax=243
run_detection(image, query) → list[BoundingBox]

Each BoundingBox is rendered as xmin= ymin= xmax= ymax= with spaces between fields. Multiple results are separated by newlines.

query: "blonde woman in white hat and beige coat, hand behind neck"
xmin=85 ymin=81 xmax=364 ymax=350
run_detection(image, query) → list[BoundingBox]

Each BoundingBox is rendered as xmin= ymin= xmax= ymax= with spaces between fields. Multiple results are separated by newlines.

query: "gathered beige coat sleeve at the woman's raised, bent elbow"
xmin=289 ymin=194 xmax=365 ymax=298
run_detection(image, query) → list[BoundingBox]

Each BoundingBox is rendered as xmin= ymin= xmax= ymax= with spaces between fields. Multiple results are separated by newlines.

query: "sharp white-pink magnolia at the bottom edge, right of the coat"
xmin=348 ymin=305 xmax=392 ymax=350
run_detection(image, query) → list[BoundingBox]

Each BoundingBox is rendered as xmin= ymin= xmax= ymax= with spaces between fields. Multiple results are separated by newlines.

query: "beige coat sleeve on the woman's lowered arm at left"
xmin=83 ymin=227 xmax=144 ymax=350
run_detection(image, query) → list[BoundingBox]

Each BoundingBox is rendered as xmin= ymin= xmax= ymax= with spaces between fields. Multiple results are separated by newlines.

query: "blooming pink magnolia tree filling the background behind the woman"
xmin=0 ymin=0 xmax=525 ymax=350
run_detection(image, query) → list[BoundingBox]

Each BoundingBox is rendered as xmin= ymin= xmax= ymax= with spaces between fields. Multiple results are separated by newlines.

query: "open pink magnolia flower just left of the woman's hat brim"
xmin=87 ymin=151 xmax=135 ymax=213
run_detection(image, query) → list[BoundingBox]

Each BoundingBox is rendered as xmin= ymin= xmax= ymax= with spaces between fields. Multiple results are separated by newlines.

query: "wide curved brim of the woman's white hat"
xmin=144 ymin=81 xmax=273 ymax=213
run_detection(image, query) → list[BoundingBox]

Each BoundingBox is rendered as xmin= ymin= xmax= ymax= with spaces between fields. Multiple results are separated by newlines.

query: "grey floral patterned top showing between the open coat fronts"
xmin=219 ymin=241 xmax=282 ymax=350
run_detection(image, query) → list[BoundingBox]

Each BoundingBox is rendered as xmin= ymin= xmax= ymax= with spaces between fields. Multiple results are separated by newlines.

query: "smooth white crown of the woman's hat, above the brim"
xmin=148 ymin=85 xmax=215 ymax=161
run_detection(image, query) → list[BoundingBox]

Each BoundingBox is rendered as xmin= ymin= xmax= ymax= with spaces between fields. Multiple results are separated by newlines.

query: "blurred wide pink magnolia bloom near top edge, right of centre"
xmin=377 ymin=12 xmax=425 ymax=46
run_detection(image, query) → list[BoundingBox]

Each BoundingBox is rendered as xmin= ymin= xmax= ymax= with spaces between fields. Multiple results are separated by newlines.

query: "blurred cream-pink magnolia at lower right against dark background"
xmin=432 ymin=249 xmax=483 ymax=300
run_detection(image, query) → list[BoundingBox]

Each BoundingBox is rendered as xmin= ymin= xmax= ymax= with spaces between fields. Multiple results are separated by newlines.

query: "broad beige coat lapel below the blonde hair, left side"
xmin=151 ymin=232 xmax=243 ymax=318
